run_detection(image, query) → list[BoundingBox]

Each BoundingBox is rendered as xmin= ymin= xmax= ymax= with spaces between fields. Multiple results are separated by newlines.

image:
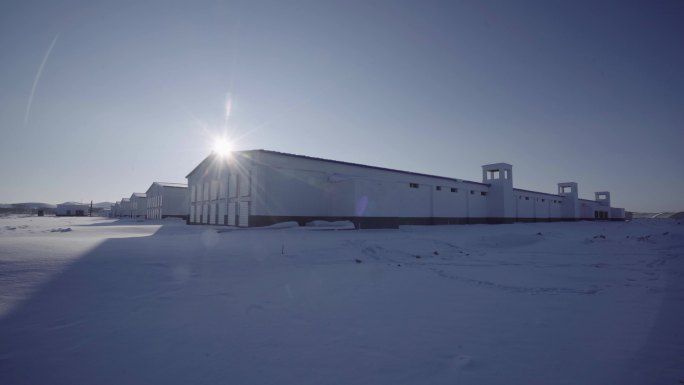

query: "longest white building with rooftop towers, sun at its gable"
xmin=187 ymin=150 xmax=625 ymax=228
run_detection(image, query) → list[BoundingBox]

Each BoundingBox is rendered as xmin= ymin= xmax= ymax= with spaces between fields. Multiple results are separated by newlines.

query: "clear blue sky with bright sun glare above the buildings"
xmin=0 ymin=0 xmax=684 ymax=211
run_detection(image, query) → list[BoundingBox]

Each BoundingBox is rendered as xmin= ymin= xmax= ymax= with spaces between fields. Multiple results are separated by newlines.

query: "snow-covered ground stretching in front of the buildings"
xmin=0 ymin=217 xmax=684 ymax=385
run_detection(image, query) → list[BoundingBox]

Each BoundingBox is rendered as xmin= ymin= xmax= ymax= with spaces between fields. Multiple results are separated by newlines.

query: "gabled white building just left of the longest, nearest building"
xmin=146 ymin=182 xmax=190 ymax=219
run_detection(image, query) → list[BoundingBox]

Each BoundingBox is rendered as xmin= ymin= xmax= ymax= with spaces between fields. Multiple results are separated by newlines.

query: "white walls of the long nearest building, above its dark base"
xmin=188 ymin=151 xmax=624 ymax=224
